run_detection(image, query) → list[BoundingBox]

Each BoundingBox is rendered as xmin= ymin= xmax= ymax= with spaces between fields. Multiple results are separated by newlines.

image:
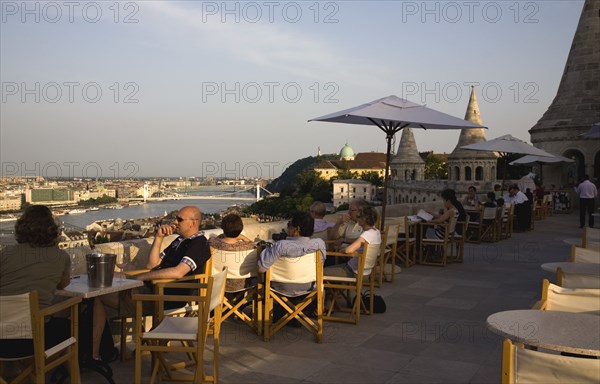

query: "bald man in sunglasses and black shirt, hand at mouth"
xmin=92 ymin=206 xmax=210 ymax=360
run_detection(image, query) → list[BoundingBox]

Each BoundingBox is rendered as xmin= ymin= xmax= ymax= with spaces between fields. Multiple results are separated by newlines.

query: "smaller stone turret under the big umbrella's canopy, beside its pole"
xmin=390 ymin=128 xmax=425 ymax=181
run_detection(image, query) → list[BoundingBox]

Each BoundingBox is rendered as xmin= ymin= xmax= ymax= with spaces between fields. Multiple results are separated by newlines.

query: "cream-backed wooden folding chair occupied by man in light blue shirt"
xmin=263 ymin=251 xmax=323 ymax=343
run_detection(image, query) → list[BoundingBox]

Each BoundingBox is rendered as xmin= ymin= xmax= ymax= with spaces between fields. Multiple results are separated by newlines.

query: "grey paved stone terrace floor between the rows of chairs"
xmin=82 ymin=212 xmax=582 ymax=384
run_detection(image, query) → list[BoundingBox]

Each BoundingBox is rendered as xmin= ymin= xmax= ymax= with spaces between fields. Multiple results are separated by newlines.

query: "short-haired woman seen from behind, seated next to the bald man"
xmin=208 ymin=214 xmax=255 ymax=292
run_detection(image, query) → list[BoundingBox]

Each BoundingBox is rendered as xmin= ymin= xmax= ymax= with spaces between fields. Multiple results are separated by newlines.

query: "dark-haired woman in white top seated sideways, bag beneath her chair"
xmin=323 ymin=206 xmax=381 ymax=277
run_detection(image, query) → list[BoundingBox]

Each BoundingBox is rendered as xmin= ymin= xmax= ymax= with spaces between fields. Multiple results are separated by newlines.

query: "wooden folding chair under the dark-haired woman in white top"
xmin=323 ymin=244 xmax=380 ymax=325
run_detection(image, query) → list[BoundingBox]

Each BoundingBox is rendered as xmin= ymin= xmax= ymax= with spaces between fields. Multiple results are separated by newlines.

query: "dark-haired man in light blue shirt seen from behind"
xmin=258 ymin=212 xmax=327 ymax=296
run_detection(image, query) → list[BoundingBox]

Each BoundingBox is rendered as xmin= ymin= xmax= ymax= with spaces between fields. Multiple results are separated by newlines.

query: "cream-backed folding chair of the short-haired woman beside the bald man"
xmin=211 ymin=247 xmax=263 ymax=335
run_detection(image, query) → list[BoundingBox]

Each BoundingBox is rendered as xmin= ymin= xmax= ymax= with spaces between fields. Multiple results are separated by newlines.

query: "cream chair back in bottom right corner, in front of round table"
xmin=501 ymin=339 xmax=600 ymax=384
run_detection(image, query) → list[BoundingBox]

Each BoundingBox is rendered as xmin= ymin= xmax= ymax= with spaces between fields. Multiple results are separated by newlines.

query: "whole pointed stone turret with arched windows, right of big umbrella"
xmin=448 ymin=87 xmax=496 ymax=182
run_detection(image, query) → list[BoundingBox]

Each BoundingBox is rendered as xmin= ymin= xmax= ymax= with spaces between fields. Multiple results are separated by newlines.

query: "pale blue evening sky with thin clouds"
xmin=0 ymin=0 xmax=583 ymax=178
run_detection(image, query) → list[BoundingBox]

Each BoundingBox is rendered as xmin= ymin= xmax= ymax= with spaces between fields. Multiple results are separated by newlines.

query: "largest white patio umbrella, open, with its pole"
xmin=309 ymin=95 xmax=486 ymax=228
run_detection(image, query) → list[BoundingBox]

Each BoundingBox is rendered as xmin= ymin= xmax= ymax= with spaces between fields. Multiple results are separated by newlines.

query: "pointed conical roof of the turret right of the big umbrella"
xmin=448 ymin=86 xmax=496 ymax=160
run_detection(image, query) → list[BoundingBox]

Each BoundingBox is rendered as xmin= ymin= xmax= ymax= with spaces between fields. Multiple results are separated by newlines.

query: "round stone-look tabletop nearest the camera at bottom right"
xmin=487 ymin=309 xmax=600 ymax=356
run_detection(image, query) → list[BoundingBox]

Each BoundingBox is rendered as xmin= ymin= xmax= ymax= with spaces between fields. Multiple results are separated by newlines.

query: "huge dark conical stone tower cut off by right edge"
xmin=529 ymin=0 xmax=600 ymax=184
